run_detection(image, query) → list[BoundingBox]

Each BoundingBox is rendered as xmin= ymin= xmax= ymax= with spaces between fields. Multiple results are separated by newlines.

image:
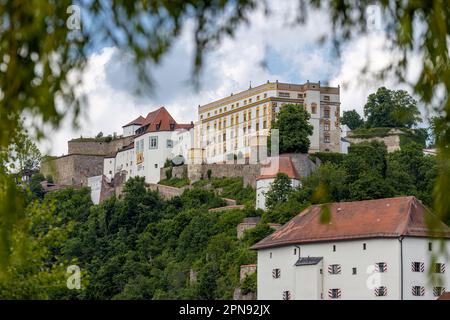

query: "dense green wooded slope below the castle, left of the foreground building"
xmin=0 ymin=178 xmax=270 ymax=299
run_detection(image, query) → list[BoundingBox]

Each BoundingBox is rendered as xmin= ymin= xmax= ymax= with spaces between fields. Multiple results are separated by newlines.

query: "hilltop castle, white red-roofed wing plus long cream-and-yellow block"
xmin=103 ymin=81 xmax=341 ymax=184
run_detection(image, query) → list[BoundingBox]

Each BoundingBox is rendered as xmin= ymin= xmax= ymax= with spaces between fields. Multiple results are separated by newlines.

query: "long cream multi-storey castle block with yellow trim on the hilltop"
xmin=195 ymin=81 xmax=340 ymax=163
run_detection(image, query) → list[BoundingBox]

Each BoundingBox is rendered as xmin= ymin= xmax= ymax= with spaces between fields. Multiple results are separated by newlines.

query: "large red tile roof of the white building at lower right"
xmin=252 ymin=197 xmax=450 ymax=249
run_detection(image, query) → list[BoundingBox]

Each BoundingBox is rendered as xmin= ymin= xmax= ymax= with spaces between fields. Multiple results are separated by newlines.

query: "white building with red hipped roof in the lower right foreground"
xmin=252 ymin=197 xmax=450 ymax=300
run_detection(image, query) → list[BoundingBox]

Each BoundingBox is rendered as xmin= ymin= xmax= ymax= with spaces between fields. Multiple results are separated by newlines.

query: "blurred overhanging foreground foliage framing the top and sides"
xmin=4 ymin=0 xmax=450 ymax=276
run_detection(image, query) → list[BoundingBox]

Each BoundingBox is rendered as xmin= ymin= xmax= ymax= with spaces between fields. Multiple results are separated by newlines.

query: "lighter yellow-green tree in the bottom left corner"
xmin=0 ymin=201 xmax=74 ymax=300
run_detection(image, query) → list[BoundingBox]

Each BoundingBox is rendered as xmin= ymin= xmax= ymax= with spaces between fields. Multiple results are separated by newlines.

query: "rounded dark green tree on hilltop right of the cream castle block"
xmin=364 ymin=87 xmax=422 ymax=128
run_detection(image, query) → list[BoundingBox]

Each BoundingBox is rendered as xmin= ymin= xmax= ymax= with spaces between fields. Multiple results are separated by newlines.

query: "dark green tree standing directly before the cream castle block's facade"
xmin=269 ymin=104 xmax=313 ymax=153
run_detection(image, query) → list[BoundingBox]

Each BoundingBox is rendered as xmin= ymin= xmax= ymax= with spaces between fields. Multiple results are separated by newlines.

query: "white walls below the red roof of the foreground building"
xmin=257 ymin=238 xmax=450 ymax=300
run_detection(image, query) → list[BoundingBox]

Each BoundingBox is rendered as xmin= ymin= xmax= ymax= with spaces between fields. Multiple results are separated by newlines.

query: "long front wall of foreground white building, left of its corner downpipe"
xmin=257 ymin=239 xmax=400 ymax=300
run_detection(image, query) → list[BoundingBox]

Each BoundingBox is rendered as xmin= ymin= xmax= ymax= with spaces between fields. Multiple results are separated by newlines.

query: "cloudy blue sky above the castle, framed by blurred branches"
xmin=39 ymin=0 xmax=420 ymax=156
